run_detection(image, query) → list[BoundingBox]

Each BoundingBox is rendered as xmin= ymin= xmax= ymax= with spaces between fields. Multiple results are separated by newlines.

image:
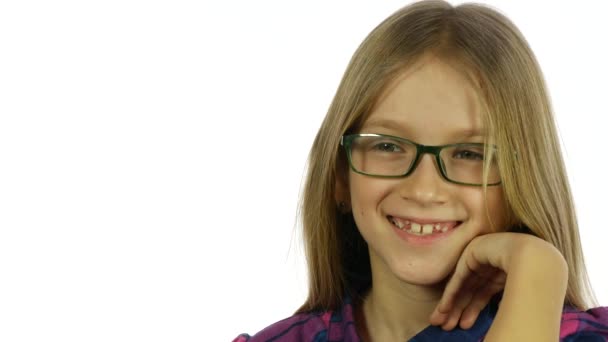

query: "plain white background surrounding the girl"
xmin=0 ymin=0 xmax=608 ymax=341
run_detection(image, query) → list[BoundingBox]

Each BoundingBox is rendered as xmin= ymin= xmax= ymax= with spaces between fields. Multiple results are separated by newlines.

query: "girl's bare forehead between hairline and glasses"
xmin=363 ymin=58 xmax=485 ymax=143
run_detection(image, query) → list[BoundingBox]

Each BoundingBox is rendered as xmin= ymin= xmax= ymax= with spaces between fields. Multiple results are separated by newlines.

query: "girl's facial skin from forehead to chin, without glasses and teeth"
xmin=348 ymin=58 xmax=506 ymax=285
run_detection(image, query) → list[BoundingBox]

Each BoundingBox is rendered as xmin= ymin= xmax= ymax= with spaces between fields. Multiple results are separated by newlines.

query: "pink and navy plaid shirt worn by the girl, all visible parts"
xmin=233 ymin=298 xmax=608 ymax=342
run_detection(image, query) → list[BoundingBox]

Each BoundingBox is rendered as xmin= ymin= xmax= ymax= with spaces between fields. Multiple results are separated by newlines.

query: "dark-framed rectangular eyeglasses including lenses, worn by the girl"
xmin=340 ymin=133 xmax=501 ymax=186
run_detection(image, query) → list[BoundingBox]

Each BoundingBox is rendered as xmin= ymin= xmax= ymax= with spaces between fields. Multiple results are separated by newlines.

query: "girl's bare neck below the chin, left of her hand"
xmin=356 ymin=253 xmax=445 ymax=342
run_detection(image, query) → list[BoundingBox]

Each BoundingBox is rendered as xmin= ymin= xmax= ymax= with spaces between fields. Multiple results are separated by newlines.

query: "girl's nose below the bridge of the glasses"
xmin=399 ymin=154 xmax=446 ymax=205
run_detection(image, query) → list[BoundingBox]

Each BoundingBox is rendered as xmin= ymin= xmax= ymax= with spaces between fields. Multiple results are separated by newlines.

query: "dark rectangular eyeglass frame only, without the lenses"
xmin=340 ymin=133 xmax=502 ymax=186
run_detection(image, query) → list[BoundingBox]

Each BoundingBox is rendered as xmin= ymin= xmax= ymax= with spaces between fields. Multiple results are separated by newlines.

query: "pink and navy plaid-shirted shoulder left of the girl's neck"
xmin=232 ymin=300 xmax=359 ymax=342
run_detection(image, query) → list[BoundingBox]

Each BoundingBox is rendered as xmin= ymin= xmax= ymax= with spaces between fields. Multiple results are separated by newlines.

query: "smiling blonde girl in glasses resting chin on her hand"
xmin=234 ymin=1 xmax=608 ymax=342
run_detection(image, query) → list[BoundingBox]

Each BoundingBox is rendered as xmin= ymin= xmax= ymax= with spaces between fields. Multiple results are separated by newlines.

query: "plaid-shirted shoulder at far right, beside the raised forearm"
xmin=560 ymin=306 xmax=608 ymax=341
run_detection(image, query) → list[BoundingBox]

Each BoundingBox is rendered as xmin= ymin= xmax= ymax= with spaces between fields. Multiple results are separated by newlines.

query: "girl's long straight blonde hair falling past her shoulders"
xmin=296 ymin=0 xmax=597 ymax=313
